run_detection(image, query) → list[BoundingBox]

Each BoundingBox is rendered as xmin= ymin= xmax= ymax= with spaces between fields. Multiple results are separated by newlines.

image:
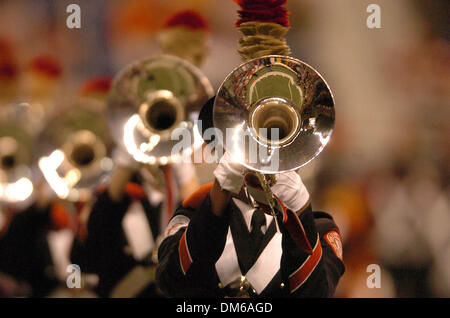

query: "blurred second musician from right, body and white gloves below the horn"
xmin=72 ymin=145 xmax=195 ymax=297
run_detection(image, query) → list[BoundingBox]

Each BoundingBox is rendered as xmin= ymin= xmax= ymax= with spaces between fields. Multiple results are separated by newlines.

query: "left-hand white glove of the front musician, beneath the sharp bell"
xmin=214 ymin=152 xmax=244 ymax=194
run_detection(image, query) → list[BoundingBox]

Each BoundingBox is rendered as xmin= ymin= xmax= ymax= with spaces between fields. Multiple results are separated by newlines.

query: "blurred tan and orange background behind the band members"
xmin=0 ymin=0 xmax=450 ymax=298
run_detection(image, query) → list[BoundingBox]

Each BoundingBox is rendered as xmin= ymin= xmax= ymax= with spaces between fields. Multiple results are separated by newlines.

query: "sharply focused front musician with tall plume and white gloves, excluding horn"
xmin=156 ymin=0 xmax=345 ymax=297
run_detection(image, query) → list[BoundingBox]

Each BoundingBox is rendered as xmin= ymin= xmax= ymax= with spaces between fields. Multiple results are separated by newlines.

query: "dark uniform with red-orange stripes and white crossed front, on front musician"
xmin=156 ymin=185 xmax=345 ymax=297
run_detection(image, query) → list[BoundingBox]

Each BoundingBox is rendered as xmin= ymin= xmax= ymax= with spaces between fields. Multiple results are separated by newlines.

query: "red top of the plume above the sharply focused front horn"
xmin=233 ymin=0 xmax=290 ymax=27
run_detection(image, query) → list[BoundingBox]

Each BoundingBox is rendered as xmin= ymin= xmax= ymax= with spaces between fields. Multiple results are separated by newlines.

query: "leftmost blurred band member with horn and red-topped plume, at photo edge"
xmin=0 ymin=56 xmax=68 ymax=297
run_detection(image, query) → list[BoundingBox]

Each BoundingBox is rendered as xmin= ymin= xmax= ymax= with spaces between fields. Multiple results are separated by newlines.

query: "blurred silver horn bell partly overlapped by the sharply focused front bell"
xmin=108 ymin=55 xmax=213 ymax=164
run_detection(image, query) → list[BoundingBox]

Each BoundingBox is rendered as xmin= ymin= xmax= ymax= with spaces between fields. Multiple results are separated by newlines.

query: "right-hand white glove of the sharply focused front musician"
xmin=271 ymin=171 xmax=309 ymax=212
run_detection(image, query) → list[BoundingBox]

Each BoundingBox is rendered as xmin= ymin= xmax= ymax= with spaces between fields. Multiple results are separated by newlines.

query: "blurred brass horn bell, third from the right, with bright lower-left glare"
xmin=38 ymin=104 xmax=113 ymax=201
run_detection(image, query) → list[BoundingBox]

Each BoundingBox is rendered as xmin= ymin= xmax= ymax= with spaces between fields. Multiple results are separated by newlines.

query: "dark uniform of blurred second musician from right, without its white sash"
xmin=71 ymin=179 xmax=165 ymax=297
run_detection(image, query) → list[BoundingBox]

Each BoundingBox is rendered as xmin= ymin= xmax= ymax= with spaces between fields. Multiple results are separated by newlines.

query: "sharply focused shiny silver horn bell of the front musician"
xmin=213 ymin=55 xmax=335 ymax=174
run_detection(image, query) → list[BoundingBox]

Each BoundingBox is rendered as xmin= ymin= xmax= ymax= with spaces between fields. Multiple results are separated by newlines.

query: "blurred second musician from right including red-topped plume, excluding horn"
xmin=72 ymin=11 xmax=208 ymax=297
